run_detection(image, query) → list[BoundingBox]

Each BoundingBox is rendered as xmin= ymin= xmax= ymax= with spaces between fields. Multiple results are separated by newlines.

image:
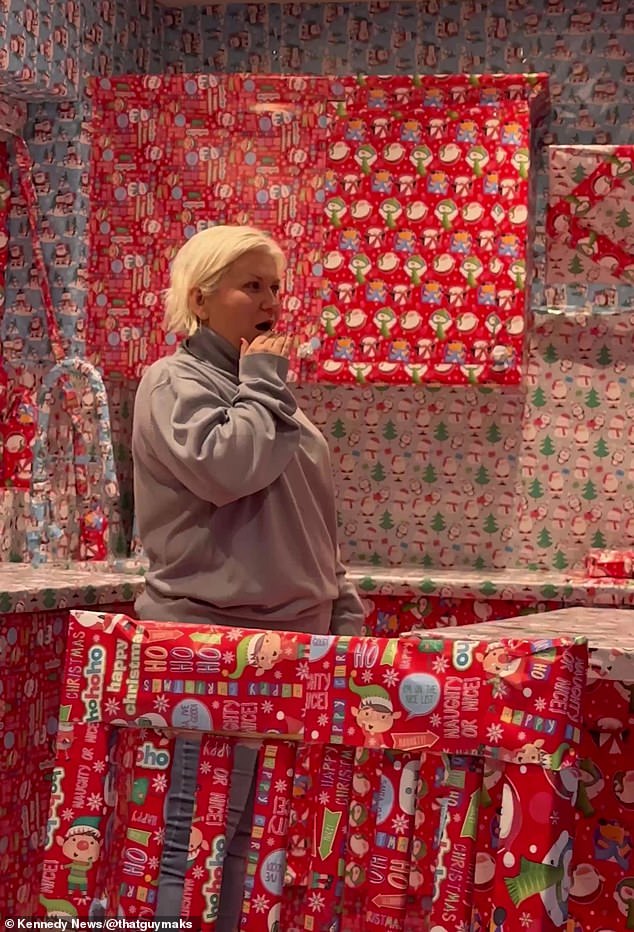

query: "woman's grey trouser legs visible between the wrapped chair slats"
xmin=156 ymin=738 xmax=258 ymax=932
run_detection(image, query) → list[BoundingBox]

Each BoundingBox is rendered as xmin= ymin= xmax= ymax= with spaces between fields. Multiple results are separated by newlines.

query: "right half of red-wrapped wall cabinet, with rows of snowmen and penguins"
xmin=317 ymin=75 xmax=546 ymax=385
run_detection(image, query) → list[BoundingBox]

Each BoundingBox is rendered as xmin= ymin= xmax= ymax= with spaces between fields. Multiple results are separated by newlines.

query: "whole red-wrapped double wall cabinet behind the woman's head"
xmin=88 ymin=75 xmax=547 ymax=385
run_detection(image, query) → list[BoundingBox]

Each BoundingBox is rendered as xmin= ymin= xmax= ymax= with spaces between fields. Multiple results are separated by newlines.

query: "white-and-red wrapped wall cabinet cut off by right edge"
xmin=546 ymin=146 xmax=634 ymax=285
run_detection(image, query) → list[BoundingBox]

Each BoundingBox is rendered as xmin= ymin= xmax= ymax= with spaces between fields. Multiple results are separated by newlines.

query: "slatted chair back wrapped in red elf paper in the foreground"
xmin=41 ymin=611 xmax=587 ymax=932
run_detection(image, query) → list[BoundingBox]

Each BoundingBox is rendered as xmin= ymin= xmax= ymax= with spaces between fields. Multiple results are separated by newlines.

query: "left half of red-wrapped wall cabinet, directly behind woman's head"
xmin=87 ymin=74 xmax=330 ymax=379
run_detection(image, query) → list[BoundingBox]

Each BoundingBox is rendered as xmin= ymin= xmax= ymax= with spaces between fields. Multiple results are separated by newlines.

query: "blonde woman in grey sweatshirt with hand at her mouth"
xmin=132 ymin=226 xmax=363 ymax=932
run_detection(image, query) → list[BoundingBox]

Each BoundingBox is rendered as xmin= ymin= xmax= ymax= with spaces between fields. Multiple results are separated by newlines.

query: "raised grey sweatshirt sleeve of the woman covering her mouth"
xmin=141 ymin=353 xmax=300 ymax=506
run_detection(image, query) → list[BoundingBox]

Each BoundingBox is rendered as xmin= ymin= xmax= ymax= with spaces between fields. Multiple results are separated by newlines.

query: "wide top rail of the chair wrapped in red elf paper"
xmin=59 ymin=611 xmax=583 ymax=765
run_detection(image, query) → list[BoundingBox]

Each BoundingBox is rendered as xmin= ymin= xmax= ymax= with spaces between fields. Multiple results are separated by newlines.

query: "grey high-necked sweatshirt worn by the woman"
xmin=132 ymin=328 xmax=363 ymax=634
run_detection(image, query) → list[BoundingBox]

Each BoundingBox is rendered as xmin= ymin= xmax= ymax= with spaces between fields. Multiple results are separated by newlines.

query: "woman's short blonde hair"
xmin=164 ymin=226 xmax=285 ymax=334
